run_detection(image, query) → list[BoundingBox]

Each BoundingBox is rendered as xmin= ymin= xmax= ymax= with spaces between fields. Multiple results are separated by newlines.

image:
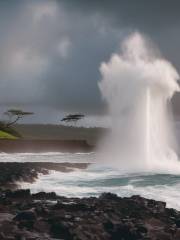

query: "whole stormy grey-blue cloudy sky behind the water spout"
xmin=0 ymin=0 xmax=180 ymax=124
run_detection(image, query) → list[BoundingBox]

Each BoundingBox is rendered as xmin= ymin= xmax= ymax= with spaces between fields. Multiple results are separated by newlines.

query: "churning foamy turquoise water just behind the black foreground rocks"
xmin=18 ymin=165 xmax=180 ymax=210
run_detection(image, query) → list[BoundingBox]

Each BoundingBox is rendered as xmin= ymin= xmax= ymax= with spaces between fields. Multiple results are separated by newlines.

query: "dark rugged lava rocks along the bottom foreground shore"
xmin=0 ymin=190 xmax=180 ymax=240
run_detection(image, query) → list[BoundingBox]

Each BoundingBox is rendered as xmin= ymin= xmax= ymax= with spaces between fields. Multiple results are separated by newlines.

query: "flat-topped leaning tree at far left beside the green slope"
xmin=4 ymin=109 xmax=34 ymax=127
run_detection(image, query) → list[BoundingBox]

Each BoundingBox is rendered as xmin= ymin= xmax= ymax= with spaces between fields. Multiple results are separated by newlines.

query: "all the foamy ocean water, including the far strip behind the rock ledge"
xmin=0 ymin=152 xmax=180 ymax=210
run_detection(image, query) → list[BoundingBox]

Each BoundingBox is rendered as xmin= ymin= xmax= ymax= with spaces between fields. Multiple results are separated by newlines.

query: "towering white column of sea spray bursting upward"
xmin=99 ymin=32 xmax=180 ymax=172
